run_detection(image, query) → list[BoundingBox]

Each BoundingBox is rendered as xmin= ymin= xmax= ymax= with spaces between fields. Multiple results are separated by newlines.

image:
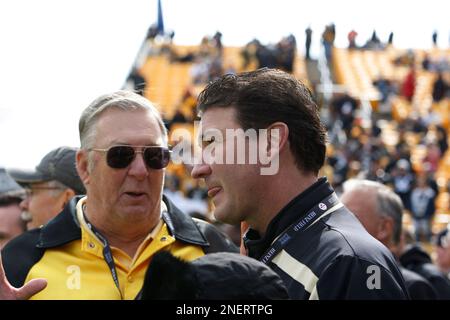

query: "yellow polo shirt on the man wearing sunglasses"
xmin=25 ymin=198 xmax=204 ymax=300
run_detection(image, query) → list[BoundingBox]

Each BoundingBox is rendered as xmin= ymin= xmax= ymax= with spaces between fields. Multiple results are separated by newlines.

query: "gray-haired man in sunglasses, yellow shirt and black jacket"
xmin=0 ymin=91 xmax=236 ymax=299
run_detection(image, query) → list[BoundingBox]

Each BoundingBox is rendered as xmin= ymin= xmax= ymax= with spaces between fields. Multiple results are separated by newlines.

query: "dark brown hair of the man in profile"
xmin=197 ymin=68 xmax=326 ymax=173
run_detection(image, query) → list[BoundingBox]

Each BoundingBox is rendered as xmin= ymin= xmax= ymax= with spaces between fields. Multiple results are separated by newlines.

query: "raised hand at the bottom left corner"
xmin=0 ymin=253 xmax=47 ymax=300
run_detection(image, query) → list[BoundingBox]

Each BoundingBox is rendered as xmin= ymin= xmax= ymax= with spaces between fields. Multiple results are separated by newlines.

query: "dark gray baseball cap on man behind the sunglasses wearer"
xmin=8 ymin=147 xmax=86 ymax=194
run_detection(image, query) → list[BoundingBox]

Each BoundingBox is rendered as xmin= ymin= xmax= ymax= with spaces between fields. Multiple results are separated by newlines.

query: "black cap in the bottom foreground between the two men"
xmin=140 ymin=251 xmax=288 ymax=300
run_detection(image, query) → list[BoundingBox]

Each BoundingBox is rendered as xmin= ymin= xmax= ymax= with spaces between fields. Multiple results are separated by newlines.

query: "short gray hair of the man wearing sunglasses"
xmin=78 ymin=90 xmax=167 ymax=149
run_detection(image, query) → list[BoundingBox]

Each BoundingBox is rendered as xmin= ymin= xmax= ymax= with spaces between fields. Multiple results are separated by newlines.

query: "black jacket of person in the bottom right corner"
xmin=400 ymin=245 xmax=450 ymax=300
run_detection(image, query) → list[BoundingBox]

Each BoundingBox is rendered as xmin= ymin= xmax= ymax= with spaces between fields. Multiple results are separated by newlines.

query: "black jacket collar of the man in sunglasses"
xmin=36 ymin=196 xmax=209 ymax=249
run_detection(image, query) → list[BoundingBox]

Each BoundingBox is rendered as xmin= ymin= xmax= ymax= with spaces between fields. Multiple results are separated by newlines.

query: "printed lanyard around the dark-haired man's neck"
xmin=260 ymin=192 xmax=344 ymax=264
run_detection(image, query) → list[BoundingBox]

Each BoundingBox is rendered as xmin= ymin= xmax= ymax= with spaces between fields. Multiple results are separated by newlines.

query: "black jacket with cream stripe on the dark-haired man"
xmin=244 ymin=178 xmax=408 ymax=299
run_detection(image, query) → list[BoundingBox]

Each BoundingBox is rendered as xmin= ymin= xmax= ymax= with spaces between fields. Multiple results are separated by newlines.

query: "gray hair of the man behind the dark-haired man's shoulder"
xmin=343 ymin=179 xmax=403 ymax=244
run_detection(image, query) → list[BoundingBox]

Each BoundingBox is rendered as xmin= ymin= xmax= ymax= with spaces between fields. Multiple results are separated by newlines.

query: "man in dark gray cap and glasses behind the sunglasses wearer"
xmin=8 ymin=147 xmax=86 ymax=229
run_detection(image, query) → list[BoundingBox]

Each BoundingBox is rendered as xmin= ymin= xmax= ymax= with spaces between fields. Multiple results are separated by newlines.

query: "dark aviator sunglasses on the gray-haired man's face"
xmin=89 ymin=146 xmax=171 ymax=169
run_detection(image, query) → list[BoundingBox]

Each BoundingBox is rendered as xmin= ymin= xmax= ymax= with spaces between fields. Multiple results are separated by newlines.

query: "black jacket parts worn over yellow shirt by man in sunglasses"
xmin=2 ymin=196 xmax=239 ymax=287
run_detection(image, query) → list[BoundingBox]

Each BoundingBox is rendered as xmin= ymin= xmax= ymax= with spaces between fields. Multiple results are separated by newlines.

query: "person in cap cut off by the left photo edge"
xmin=0 ymin=168 xmax=26 ymax=250
